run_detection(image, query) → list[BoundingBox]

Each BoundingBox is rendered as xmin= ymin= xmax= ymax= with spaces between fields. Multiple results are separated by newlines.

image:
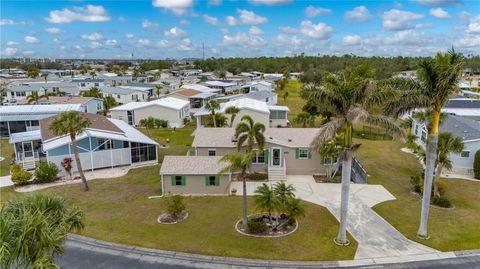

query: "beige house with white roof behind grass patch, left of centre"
xmin=110 ymin=97 xmax=190 ymax=128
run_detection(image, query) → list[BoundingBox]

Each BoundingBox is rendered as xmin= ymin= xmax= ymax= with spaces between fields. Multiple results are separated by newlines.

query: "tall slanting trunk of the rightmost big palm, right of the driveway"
xmin=417 ymin=110 xmax=440 ymax=238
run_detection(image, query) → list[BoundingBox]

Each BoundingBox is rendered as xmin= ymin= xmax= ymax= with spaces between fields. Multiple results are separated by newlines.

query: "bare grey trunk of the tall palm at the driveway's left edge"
xmin=335 ymin=148 xmax=353 ymax=245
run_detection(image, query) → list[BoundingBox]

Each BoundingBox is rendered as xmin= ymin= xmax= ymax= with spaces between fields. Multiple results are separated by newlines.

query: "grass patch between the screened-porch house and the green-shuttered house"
xmin=138 ymin=124 xmax=195 ymax=162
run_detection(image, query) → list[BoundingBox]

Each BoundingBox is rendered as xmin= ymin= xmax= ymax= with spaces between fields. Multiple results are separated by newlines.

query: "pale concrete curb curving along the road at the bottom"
xmin=66 ymin=234 xmax=480 ymax=268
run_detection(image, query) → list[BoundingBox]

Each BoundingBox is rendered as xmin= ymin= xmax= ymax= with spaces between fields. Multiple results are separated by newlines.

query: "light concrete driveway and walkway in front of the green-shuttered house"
xmin=232 ymin=175 xmax=439 ymax=259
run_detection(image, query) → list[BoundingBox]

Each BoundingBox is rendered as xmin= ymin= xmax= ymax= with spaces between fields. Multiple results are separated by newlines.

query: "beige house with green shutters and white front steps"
xmin=160 ymin=128 xmax=327 ymax=194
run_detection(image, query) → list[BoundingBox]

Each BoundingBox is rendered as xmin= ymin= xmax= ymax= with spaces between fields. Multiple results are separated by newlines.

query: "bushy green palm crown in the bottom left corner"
xmin=0 ymin=194 xmax=85 ymax=268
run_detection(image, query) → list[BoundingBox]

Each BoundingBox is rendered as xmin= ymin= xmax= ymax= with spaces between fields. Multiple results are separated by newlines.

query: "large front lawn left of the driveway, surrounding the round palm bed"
xmin=0 ymin=165 xmax=357 ymax=260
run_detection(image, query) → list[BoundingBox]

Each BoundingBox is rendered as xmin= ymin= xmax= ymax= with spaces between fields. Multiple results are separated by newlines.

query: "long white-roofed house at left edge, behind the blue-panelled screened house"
xmin=0 ymin=104 xmax=82 ymax=137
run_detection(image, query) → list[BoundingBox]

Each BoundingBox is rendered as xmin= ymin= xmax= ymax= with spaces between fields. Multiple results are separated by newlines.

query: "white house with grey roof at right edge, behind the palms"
xmin=412 ymin=115 xmax=480 ymax=176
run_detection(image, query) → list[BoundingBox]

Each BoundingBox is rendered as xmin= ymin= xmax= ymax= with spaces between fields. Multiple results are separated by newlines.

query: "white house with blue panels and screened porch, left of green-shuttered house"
xmin=10 ymin=113 xmax=158 ymax=171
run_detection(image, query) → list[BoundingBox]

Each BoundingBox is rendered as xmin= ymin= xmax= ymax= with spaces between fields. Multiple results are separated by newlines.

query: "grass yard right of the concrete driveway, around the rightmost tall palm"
xmin=355 ymin=139 xmax=480 ymax=251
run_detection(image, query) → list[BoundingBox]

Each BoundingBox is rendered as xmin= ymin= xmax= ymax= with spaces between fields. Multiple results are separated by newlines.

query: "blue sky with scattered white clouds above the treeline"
xmin=0 ymin=0 xmax=480 ymax=59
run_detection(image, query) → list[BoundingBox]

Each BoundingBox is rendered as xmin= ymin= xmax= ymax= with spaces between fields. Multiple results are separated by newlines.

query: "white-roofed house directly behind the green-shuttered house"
xmin=194 ymin=97 xmax=289 ymax=127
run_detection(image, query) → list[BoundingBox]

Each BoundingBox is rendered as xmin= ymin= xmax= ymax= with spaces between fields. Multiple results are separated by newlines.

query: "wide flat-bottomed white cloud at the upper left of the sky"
xmin=45 ymin=5 xmax=111 ymax=23
